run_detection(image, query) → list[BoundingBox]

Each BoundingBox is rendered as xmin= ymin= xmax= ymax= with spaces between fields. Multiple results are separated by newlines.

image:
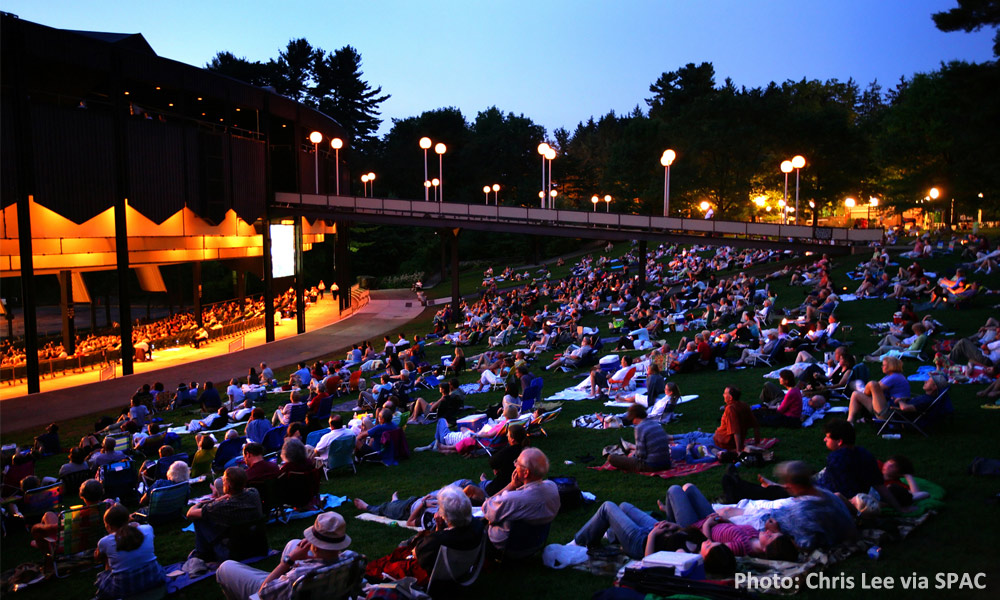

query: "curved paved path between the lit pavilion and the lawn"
xmin=0 ymin=290 xmax=423 ymax=433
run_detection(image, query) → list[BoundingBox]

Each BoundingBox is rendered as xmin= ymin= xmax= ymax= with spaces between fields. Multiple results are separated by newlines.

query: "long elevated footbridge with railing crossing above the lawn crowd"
xmin=275 ymin=193 xmax=883 ymax=245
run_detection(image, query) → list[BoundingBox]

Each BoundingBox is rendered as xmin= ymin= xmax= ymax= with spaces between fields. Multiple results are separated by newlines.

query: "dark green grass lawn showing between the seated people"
xmin=0 ymin=244 xmax=1000 ymax=600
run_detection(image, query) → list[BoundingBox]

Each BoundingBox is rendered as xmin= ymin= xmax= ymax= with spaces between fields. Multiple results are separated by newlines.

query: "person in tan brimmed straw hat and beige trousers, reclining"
xmin=215 ymin=512 xmax=357 ymax=600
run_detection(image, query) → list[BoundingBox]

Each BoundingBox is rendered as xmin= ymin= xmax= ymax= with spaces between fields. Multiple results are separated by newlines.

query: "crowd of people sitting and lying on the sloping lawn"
xmin=4 ymin=229 xmax=998 ymax=598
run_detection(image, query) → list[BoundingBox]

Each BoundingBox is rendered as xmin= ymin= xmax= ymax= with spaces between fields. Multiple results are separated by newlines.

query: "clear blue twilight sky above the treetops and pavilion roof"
xmin=0 ymin=0 xmax=993 ymax=133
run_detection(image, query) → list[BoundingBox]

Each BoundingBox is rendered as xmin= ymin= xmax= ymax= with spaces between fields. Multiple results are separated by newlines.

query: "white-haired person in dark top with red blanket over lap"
xmin=365 ymin=485 xmax=483 ymax=587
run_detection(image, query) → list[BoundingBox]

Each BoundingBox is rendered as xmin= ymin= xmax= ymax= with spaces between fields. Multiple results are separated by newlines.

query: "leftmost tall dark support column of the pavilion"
xmin=10 ymin=19 xmax=41 ymax=394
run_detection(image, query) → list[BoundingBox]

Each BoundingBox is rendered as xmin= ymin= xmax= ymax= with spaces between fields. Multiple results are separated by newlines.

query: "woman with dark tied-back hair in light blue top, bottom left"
xmin=94 ymin=504 xmax=166 ymax=600
